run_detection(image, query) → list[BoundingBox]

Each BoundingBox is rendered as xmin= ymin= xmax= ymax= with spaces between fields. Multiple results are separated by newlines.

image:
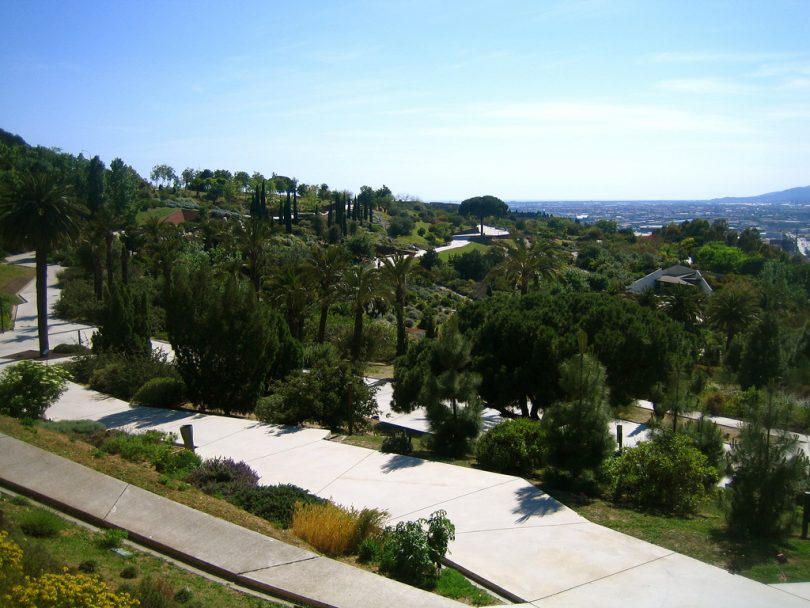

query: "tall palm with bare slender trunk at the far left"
xmin=0 ymin=172 xmax=87 ymax=357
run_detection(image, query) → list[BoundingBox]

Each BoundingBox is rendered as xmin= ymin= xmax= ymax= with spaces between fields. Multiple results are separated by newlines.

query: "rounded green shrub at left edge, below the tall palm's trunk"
xmin=0 ymin=361 xmax=70 ymax=418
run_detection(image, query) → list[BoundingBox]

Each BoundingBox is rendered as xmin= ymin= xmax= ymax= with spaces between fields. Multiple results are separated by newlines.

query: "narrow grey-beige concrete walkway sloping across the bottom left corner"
xmin=0 ymin=434 xmax=462 ymax=608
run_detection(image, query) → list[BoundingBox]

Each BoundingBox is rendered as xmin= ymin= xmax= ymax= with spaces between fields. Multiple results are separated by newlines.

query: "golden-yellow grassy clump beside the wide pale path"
xmin=292 ymin=502 xmax=387 ymax=556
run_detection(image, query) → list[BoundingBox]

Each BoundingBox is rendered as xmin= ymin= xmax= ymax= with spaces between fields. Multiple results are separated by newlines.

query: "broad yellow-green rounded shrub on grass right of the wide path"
xmin=607 ymin=433 xmax=718 ymax=514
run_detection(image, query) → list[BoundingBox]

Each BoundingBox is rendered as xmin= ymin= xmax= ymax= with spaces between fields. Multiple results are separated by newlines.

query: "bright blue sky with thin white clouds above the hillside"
xmin=0 ymin=0 xmax=810 ymax=200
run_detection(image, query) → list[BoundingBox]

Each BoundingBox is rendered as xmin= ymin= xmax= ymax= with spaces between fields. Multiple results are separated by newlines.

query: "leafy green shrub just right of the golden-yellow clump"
xmin=380 ymin=511 xmax=455 ymax=586
